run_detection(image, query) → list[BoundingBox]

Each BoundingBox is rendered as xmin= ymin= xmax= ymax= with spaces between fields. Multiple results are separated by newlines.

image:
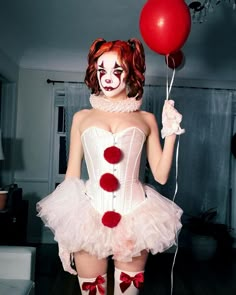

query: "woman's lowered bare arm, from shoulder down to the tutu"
xmin=65 ymin=111 xmax=84 ymax=178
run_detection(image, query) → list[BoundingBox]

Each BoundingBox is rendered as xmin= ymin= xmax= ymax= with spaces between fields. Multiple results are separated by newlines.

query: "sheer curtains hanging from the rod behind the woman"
xmin=63 ymin=84 xmax=234 ymax=223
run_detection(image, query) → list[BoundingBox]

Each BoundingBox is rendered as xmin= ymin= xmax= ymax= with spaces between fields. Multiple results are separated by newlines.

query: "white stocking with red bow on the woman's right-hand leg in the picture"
xmin=114 ymin=268 xmax=144 ymax=295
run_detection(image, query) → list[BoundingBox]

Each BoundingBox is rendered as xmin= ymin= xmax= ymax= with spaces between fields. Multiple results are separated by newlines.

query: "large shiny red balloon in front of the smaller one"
xmin=139 ymin=0 xmax=191 ymax=55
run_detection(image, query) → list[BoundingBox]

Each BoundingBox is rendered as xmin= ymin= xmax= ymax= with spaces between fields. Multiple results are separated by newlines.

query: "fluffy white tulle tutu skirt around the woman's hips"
xmin=37 ymin=178 xmax=183 ymax=262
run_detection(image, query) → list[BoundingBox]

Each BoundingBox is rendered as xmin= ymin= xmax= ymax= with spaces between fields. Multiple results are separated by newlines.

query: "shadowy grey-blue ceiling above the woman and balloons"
xmin=0 ymin=0 xmax=236 ymax=80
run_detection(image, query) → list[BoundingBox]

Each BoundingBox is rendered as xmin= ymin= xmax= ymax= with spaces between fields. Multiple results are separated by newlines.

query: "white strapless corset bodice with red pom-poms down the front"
xmin=81 ymin=127 xmax=146 ymax=214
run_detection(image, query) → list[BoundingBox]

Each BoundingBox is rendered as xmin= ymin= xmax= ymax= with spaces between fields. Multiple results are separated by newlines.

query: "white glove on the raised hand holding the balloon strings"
xmin=161 ymin=100 xmax=185 ymax=138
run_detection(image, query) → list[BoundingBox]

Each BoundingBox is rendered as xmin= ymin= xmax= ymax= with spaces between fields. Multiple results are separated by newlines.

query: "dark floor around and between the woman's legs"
xmin=36 ymin=244 xmax=236 ymax=295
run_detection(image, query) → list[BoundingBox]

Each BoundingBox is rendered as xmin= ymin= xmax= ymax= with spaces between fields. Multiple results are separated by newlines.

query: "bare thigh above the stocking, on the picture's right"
xmin=114 ymin=250 xmax=148 ymax=272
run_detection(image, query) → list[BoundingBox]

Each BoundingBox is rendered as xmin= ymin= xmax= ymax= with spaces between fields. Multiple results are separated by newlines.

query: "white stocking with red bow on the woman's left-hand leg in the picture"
xmin=78 ymin=274 xmax=107 ymax=295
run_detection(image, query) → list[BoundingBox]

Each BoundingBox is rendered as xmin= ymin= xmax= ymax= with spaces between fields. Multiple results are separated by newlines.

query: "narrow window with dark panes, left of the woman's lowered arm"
xmin=49 ymin=83 xmax=90 ymax=191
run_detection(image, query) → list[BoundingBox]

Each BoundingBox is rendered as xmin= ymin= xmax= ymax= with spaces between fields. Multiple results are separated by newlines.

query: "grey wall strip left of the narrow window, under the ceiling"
xmin=15 ymin=69 xmax=85 ymax=242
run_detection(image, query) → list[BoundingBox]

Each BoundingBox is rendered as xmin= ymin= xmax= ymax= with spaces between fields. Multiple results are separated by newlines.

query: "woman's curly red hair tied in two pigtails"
xmin=84 ymin=38 xmax=146 ymax=99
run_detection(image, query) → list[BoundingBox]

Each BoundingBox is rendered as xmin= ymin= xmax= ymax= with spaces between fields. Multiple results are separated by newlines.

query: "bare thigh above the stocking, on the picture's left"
xmin=74 ymin=251 xmax=107 ymax=278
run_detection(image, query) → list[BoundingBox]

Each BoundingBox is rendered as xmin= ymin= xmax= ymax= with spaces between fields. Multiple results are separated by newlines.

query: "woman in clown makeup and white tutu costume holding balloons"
xmin=37 ymin=39 xmax=184 ymax=295
